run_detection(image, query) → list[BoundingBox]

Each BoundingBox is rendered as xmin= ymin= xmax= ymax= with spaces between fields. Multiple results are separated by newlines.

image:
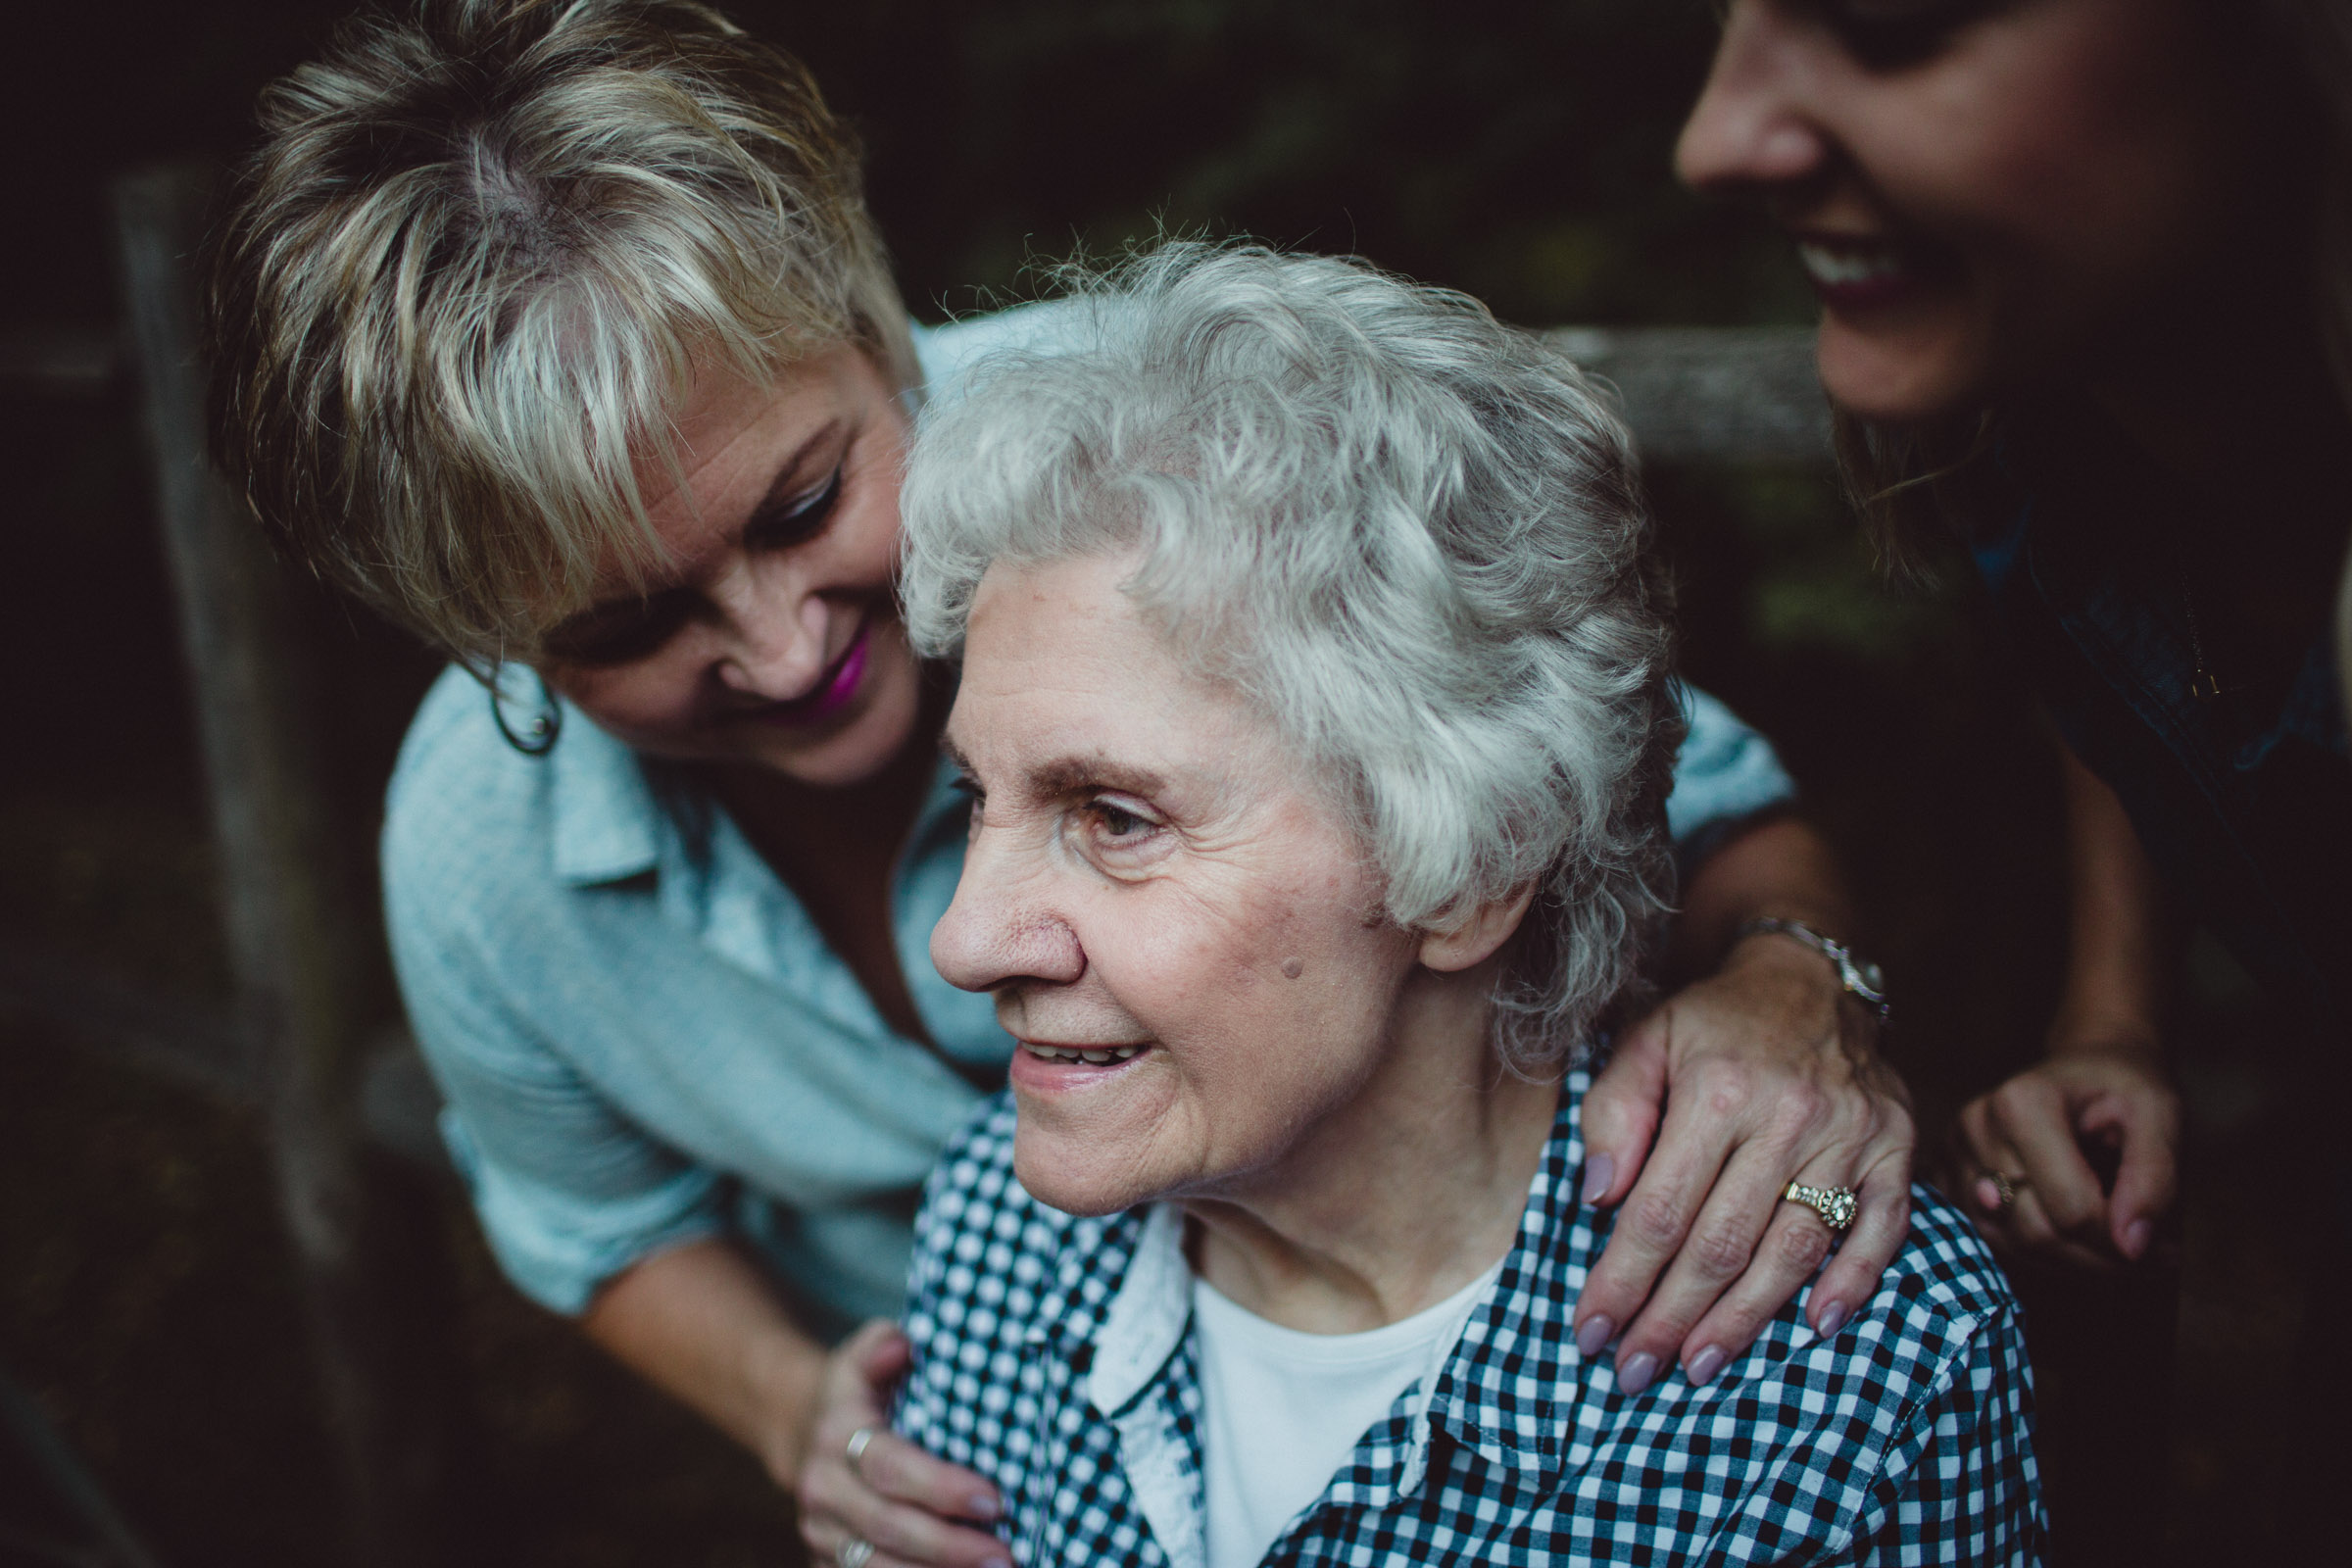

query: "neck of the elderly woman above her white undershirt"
xmin=1186 ymin=964 xmax=1559 ymax=1333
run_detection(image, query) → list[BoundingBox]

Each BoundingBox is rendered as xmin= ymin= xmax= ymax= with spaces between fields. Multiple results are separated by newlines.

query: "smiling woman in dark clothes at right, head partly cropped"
xmin=1680 ymin=0 xmax=2352 ymax=1528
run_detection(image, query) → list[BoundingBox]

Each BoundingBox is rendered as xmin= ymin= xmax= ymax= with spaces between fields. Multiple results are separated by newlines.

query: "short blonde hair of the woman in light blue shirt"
xmin=210 ymin=0 xmax=915 ymax=667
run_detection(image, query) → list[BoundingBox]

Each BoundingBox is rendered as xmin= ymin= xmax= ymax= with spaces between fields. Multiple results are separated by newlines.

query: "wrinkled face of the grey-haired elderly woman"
xmin=931 ymin=560 xmax=1418 ymax=1213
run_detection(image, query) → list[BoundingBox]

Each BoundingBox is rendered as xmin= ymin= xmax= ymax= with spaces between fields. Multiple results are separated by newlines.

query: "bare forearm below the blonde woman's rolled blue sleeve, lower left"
xmin=581 ymin=1239 xmax=825 ymax=1486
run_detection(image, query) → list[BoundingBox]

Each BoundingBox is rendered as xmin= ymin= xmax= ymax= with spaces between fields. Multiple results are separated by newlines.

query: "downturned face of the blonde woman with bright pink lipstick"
xmin=541 ymin=348 xmax=919 ymax=785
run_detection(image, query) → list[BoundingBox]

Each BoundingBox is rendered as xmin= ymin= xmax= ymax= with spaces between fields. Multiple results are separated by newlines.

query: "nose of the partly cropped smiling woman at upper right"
xmin=1675 ymin=0 xmax=1830 ymax=190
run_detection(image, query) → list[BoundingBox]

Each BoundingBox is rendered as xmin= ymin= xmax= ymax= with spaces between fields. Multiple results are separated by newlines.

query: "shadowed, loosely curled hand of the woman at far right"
xmin=1952 ymin=1042 xmax=2180 ymax=1269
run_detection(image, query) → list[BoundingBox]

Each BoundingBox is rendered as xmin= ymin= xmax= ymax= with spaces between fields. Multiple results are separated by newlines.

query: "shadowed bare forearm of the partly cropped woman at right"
xmin=2051 ymin=750 xmax=2169 ymax=1055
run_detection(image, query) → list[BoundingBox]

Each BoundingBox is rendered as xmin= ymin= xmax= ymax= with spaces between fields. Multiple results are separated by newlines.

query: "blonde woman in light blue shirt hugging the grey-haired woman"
xmin=212 ymin=0 xmax=1912 ymax=1566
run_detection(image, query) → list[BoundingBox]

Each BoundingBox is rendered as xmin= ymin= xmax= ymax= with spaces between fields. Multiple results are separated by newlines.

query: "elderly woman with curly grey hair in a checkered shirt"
xmin=889 ymin=247 xmax=2041 ymax=1568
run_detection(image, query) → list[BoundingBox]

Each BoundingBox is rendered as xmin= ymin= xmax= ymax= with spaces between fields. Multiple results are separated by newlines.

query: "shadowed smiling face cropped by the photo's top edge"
xmin=1677 ymin=0 xmax=2248 ymax=420
